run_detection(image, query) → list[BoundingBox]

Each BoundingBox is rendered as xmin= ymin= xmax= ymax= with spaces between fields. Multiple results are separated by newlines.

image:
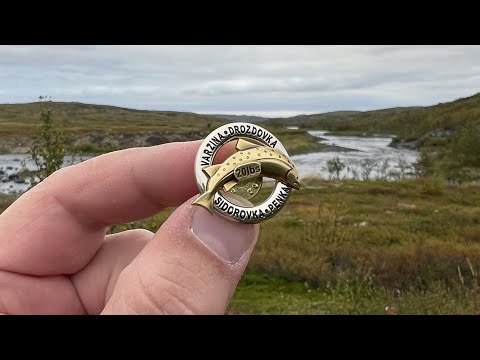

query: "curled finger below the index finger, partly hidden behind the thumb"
xmin=0 ymin=229 xmax=153 ymax=314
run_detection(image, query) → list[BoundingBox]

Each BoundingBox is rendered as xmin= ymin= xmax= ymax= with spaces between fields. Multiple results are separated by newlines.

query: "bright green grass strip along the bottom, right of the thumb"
xmin=227 ymin=271 xmax=480 ymax=315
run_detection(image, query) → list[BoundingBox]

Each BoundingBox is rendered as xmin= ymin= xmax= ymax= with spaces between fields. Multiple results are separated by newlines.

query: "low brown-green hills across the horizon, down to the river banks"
xmin=0 ymin=93 xmax=480 ymax=181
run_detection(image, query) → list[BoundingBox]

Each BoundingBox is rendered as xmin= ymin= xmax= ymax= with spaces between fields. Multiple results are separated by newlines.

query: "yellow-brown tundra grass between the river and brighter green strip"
xmin=250 ymin=180 xmax=480 ymax=289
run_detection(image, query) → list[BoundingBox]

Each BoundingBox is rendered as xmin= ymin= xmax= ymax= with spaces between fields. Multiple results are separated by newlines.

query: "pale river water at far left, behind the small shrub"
xmin=0 ymin=154 xmax=90 ymax=194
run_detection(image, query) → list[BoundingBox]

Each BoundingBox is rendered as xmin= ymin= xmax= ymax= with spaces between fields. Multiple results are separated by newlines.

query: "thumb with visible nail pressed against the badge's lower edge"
xmin=103 ymin=199 xmax=259 ymax=314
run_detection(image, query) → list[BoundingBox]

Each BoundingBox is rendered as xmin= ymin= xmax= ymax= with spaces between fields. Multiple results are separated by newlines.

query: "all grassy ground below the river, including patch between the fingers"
xmin=0 ymin=179 xmax=480 ymax=314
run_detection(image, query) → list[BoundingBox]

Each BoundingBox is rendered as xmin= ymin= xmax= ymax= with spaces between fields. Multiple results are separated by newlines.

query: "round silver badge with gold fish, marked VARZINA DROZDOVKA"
xmin=193 ymin=122 xmax=300 ymax=223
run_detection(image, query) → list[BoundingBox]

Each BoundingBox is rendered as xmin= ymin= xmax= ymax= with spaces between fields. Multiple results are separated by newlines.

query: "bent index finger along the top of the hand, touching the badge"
xmin=0 ymin=141 xmax=204 ymax=275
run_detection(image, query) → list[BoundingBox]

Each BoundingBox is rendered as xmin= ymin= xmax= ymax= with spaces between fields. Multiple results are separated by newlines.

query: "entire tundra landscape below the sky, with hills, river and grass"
xmin=0 ymin=94 xmax=480 ymax=314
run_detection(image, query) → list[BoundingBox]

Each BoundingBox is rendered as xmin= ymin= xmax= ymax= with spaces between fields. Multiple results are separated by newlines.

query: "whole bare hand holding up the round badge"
xmin=0 ymin=141 xmax=259 ymax=314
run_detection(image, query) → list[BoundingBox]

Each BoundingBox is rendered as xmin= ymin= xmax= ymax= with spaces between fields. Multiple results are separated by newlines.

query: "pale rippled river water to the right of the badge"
xmin=292 ymin=131 xmax=418 ymax=180
